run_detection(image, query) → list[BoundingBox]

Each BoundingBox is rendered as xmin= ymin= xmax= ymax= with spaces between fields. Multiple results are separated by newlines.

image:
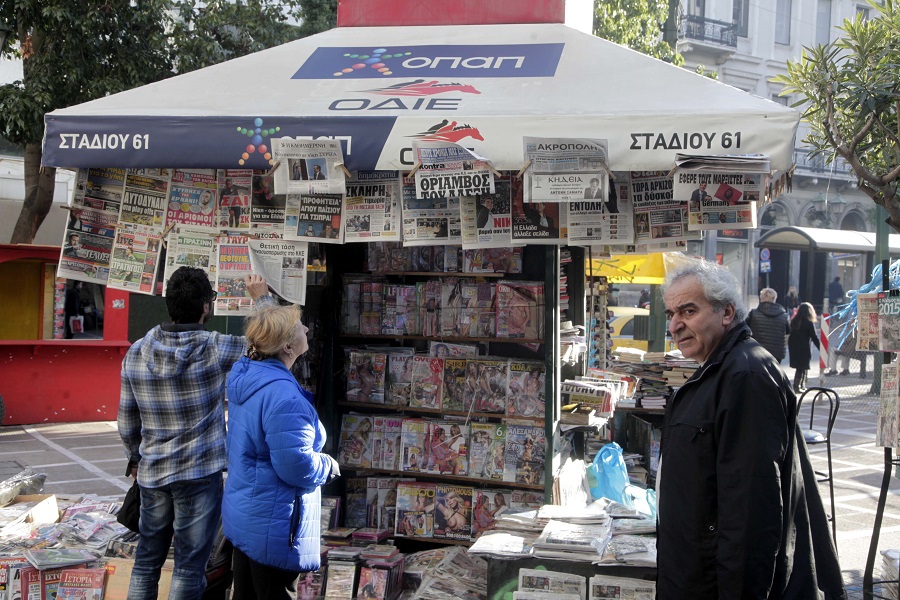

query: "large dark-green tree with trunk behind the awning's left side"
xmin=0 ymin=0 xmax=336 ymax=243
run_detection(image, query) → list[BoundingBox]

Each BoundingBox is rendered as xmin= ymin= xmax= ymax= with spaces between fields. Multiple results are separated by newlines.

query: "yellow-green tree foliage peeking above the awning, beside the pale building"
xmin=593 ymin=0 xmax=684 ymax=65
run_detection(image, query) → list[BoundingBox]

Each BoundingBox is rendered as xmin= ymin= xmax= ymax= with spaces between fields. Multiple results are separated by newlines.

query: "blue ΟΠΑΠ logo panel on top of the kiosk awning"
xmin=292 ymin=43 xmax=564 ymax=79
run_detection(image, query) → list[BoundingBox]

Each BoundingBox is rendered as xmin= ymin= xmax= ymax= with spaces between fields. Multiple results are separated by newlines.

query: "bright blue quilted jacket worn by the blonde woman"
xmin=222 ymin=357 xmax=331 ymax=571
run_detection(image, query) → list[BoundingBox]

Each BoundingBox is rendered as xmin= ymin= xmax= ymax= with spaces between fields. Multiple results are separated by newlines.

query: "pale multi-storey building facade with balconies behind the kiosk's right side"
xmin=673 ymin=0 xmax=876 ymax=306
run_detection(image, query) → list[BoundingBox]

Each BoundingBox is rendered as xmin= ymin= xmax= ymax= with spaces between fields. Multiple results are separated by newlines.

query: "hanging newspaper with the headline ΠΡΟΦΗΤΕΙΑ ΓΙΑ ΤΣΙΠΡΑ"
xmin=284 ymin=191 xmax=344 ymax=244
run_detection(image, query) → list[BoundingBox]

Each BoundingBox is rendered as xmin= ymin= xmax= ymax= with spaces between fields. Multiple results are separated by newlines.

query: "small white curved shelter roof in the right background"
xmin=754 ymin=227 xmax=900 ymax=254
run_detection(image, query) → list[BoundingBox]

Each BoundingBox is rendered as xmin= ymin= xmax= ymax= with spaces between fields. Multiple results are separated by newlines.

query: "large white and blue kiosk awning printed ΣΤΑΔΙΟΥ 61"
xmin=43 ymin=23 xmax=800 ymax=171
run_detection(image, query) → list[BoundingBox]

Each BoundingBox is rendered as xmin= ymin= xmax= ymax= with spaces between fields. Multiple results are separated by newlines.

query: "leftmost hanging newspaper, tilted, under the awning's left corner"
xmin=56 ymin=169 xmax=125 ymax=285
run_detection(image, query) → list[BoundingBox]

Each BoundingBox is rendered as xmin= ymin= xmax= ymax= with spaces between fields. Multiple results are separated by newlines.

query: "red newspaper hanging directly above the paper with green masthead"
xmin=166 ymin=169 xmax=217 ymax=227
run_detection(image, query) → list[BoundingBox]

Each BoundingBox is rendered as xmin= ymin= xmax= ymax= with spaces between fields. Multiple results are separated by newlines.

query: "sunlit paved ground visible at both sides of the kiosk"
xmin=0 ymin=392 xmax=900 ymax=600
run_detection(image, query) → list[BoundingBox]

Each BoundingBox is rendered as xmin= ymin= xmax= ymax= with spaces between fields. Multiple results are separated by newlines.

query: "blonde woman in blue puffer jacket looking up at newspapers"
xmin=222 ymin=306 xmax=340 ymax=600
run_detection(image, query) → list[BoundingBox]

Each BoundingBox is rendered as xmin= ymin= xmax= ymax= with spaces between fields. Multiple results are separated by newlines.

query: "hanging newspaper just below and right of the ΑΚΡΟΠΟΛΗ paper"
xmin=563 ymin=179 xmax=634 ymax=246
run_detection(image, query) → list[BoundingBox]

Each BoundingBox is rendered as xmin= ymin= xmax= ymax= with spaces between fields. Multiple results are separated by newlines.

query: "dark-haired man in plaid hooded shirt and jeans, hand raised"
xmin=118 ymin=267 xmax=274 ymax=600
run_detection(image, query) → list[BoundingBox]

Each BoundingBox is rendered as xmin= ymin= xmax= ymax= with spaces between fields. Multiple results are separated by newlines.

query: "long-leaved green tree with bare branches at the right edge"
xmin=774 ymin=0 xmax=900 ymax=231
